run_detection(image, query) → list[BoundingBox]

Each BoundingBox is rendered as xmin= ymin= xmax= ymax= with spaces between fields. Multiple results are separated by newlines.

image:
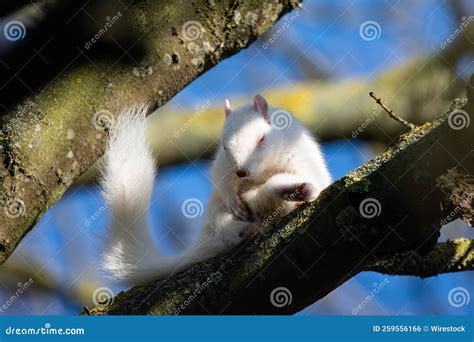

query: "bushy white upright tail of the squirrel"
xmin=102 ymin=106 xmax=176 ymax=285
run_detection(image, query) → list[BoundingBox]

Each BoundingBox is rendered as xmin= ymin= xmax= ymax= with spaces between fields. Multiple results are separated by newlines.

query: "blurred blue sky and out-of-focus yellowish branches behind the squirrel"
xmin=0 ymin=0 xmax=474 ymax=315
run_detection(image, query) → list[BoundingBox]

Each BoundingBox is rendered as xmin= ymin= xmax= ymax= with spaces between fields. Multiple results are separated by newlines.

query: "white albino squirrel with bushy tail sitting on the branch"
xmin=102 ymin=95 xmax=331 ymax=286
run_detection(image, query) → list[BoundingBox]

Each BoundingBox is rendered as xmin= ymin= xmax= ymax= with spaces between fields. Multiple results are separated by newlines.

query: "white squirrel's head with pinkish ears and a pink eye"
xmin=221 ymin=95 xmax=275 ymax=178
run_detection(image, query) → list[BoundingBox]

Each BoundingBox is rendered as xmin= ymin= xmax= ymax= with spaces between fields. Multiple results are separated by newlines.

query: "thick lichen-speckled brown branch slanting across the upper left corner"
xmin=0 ymin=0 xmax=299 ymax=263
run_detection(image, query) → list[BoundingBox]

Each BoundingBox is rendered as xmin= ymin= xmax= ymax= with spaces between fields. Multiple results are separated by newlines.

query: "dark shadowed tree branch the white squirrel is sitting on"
xmin=86 ymin=78 xmax=474 ymax=315
